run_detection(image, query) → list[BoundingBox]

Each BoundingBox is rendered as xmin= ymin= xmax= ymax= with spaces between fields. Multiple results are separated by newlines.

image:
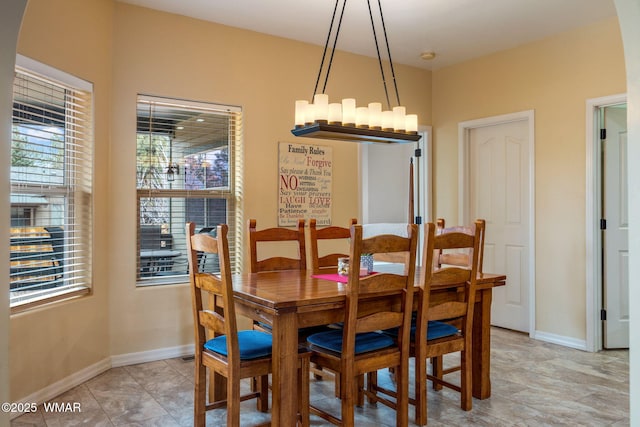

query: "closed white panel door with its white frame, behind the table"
xmin=458 ymin=110 xmax=535 ymax=336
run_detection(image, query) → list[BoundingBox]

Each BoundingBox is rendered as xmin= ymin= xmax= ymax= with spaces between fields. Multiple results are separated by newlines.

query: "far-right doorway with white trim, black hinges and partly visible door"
xmin=586 ymin=95 xmax=629 ymax=351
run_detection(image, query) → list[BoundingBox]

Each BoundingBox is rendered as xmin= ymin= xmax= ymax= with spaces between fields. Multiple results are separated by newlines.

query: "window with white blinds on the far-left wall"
xmin=9 ymin=56 xmax=93 ymax=308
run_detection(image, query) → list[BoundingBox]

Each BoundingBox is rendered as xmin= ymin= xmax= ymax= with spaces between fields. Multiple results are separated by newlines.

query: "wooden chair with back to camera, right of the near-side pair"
xmin=367 ymin=221 xmax=484 ymax=425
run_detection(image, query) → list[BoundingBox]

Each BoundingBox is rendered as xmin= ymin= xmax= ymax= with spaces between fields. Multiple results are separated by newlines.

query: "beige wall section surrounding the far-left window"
xmin=9 ymin=0 xmax=113 ymax=401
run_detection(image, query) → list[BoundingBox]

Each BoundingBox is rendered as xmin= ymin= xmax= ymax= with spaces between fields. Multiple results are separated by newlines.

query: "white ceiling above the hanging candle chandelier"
xmin=119 ymin=0 xmax=616 ymax=70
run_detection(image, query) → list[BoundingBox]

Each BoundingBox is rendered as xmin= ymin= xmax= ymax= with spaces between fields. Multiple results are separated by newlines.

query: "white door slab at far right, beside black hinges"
xmin=602 ymin=104 xmax=629 ymax=348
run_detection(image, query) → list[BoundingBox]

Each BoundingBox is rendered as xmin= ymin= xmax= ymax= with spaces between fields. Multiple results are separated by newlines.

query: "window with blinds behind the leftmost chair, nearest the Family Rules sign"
xmin=136 ymin=95 xmax=242 ymax=286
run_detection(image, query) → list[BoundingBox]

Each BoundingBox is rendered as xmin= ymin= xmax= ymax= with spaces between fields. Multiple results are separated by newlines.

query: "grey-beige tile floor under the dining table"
xmin=11 ymin=328 xmax=629 ymax=427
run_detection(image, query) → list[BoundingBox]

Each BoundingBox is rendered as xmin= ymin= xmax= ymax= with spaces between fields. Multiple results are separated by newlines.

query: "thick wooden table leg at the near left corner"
xmin=271 ymin=312 xmax=298 ymax=427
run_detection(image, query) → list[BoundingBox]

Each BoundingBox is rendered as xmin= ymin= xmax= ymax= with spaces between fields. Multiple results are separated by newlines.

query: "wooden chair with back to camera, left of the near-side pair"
xmin=307 ymin=224 xmax=418 ymax=426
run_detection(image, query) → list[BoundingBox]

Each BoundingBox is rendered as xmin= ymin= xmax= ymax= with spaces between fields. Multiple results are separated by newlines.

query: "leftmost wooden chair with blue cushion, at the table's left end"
xmin=186 ymin=222 xmax=310 ymax=427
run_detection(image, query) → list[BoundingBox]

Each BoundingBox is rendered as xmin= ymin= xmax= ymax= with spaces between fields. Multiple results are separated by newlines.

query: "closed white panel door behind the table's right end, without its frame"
xmin=468 ymin=120 xmax=533 ymax=332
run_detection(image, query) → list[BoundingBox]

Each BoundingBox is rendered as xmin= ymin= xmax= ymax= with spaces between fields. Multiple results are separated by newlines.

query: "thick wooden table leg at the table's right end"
xmin=471 ymin=289 xmax=492 ymax=399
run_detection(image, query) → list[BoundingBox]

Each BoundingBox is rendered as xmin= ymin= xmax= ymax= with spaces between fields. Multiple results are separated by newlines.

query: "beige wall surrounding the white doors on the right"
xmin=433 ymin=18 xmax=626 ymax=340
